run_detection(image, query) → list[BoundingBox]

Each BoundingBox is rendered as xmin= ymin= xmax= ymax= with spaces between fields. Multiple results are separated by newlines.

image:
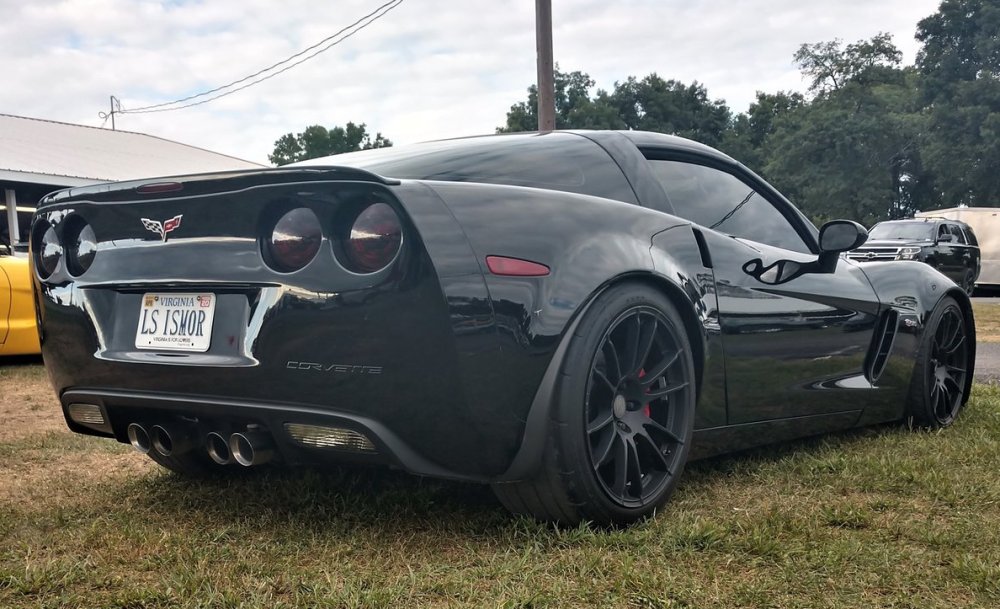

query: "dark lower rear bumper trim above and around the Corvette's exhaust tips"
xmin=60 ymin=388 xmax=488 ymax=482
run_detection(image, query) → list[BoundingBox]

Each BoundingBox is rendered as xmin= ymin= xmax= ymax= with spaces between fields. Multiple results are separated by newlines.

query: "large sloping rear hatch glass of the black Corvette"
xmin=295 ymin=133 xmax=637 ymax=203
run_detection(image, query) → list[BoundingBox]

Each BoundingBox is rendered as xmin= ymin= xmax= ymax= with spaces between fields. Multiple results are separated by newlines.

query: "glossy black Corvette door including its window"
xmin=648 ymin=154 xmax=879 ymax=424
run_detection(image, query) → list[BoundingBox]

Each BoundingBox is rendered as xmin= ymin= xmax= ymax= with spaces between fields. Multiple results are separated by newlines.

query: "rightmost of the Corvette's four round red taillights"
xmin=344 ymin=203 xmax=403 ymax=273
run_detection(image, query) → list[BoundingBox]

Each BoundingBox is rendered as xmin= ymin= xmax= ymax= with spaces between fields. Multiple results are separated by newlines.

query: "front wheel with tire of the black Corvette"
xmin=906 ymin=296 xmax=971 ymax=429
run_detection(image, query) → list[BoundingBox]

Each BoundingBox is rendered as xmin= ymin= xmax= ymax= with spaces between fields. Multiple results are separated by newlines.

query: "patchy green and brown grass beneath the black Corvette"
xmin=0 ymin=366 xmax=1000 ymax=609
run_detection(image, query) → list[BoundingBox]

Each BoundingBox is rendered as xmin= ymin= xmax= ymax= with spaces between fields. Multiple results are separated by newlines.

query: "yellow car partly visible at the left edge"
xmin=0 ymin=244 xmax=41 ymax=356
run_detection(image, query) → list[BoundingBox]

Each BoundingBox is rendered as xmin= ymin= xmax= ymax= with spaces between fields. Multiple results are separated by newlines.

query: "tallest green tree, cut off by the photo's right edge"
xmin=917 ymin=0 xmax=1000 ymax=206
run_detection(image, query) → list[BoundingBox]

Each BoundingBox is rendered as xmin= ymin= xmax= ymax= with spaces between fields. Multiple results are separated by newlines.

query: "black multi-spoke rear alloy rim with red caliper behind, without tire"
xmin=585 ymin=306 xmax=693 ymax=508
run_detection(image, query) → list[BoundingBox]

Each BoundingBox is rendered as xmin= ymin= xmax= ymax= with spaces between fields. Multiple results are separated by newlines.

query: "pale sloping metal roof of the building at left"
xmin=0 ymin=114 xmax=264 ymax=186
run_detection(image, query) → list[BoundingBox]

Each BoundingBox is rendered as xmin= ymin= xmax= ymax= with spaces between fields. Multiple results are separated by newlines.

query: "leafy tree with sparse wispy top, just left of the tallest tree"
xmin=762 ymin=34 xmax=928 ymax=224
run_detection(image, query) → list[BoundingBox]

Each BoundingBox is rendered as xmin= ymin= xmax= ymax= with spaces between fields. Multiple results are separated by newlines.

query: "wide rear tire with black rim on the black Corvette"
xmin=493 ymin=283 xmax=695 ymax=526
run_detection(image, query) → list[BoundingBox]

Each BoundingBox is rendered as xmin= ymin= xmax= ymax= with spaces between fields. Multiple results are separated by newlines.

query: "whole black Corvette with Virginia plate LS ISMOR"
xmin=32 ymin=132 xmax=975 ymax=523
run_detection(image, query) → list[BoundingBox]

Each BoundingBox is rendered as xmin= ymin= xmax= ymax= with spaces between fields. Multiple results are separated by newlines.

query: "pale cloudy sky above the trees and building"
xmin=0 ymin=0 xmax=939 ymax=163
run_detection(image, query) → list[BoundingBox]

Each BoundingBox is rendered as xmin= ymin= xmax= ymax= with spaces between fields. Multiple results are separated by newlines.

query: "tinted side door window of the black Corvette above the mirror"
xmin=649 ymin=160 xmax=809 ymax=254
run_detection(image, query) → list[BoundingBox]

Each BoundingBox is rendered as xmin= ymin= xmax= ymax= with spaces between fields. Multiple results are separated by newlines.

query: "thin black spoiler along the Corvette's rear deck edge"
xmin=38 ymin=165 xmax=399 ymax=210
